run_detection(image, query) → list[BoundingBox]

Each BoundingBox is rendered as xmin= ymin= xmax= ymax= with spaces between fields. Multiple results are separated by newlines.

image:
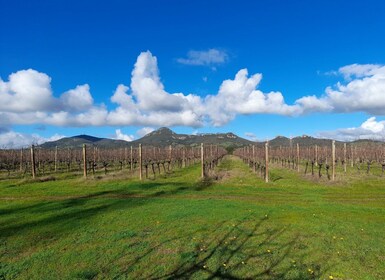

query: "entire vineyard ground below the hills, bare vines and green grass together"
xmin=0 ymin=143 xmax=385 ymax=280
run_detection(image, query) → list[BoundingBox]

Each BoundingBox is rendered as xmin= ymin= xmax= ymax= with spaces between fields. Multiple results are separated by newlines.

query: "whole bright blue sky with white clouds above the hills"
xmin=0 ymin=0 xmax=385 ymax=148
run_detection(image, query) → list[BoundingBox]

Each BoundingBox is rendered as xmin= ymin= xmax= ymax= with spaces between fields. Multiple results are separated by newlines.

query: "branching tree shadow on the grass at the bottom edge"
xmin=118 ymin=216 xmax=330 ymax=280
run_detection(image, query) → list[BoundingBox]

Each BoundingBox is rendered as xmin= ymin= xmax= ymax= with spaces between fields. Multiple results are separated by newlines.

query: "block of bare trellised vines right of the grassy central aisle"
xmin=234 ymin=141 xmax=385 ymax=181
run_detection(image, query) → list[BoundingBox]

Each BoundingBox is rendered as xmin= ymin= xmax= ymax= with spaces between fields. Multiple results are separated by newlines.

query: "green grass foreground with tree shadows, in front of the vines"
xmin=0 ymin=156 xmax=385 ymax=279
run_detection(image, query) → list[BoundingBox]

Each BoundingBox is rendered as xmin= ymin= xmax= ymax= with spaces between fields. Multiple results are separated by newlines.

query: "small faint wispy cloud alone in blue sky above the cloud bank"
xmin=177 ymin=49 xmax=229 ymax=66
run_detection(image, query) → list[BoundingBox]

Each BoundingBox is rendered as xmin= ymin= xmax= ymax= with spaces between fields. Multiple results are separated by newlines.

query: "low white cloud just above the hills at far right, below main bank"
xmin=317 ymin=117 xmax=385 ymax=141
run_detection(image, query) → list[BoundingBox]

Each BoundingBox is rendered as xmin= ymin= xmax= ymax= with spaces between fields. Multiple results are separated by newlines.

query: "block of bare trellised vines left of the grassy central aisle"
xmin=0 ymin=144 xmax=226 ymax=179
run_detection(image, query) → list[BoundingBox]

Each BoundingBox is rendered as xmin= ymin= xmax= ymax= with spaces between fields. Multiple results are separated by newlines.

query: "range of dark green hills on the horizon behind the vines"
xmin=40 ymin=127 xmax=383 ymax=148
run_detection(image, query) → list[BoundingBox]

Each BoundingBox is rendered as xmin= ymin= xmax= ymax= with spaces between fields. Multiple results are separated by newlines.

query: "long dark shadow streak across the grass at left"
xmin=0 ymin=182 xmax=196 ymax=241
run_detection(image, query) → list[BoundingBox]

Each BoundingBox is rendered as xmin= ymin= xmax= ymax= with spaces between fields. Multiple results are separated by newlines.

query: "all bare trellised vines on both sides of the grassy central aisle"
xmin=0 ymin=141 xmax=385 ymax=182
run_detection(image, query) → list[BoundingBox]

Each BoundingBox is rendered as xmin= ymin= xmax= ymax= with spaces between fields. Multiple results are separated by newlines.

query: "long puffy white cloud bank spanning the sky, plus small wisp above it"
xmin=0 ymin=49 xmax=385 ymax=132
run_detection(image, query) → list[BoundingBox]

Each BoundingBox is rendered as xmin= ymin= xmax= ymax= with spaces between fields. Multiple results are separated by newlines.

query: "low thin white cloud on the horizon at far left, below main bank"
xmin=0 ymin=131 xmax=65 ymax=149
